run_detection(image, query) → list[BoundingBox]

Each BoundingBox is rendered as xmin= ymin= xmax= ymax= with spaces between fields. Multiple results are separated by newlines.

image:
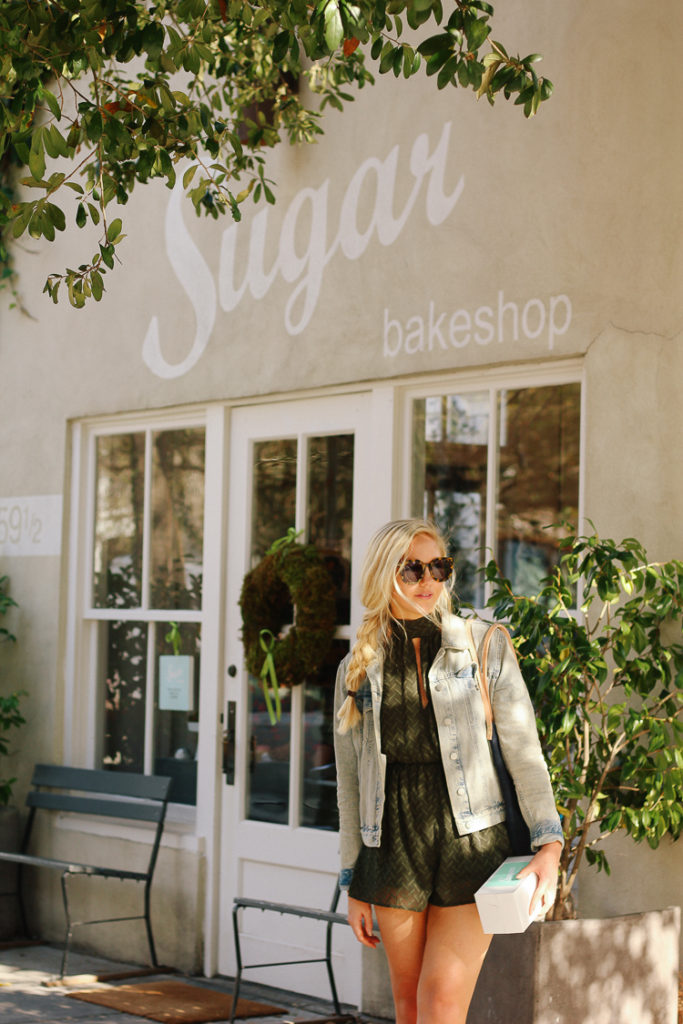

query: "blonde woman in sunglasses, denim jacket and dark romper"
xmin=335 ymin=519 xmax=562 ymax=1024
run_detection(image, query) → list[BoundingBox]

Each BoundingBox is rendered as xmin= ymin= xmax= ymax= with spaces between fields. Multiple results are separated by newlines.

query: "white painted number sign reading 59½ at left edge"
xmin=0 ymin=495 xmax=61 ymax=558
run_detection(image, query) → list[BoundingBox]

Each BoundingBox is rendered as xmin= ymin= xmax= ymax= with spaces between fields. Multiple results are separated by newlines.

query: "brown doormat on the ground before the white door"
xmin=69 ymin=981 xmax=286 ymax=1024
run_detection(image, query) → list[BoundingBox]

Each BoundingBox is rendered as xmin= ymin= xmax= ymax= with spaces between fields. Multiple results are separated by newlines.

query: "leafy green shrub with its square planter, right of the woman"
xmin=468 ymin=534 xmax=683 ymax=1024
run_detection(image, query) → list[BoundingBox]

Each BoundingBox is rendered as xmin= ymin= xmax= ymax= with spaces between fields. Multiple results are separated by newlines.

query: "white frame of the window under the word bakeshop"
xmin=397 ymin=359 xmax=586 ymax=613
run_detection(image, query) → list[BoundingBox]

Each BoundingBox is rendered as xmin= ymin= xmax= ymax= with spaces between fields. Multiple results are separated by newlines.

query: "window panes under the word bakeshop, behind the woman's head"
xmin=411 ymin=382 xmax=581 ymax=607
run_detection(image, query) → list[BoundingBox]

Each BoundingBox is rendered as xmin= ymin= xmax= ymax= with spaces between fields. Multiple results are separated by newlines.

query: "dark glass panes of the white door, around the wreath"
xmin=247 ymin=432 xmax=354 ymax=829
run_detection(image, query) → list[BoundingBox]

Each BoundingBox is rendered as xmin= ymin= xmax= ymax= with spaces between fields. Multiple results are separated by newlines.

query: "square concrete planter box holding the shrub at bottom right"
xmin=467 ymin=907 xmax=681 ymax=1024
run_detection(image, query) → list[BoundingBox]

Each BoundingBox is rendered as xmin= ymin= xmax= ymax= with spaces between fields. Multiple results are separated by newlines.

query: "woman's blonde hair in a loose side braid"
xmin=337 ymin=519 xmax=453 ymax=733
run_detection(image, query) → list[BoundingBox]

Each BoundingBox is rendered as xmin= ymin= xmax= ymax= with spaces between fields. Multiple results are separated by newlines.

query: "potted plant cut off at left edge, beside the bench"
xmin=0 ymin=575 xmax=25 ymax=939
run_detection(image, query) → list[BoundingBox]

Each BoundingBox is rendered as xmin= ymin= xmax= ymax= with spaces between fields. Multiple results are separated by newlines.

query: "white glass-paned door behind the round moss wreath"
xmin=218 ymin=395 xmax=378 ymax=1001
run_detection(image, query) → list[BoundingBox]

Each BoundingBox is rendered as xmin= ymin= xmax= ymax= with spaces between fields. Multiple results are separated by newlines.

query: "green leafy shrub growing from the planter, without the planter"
xmin=486 ymin=535 xmax=683 ymax=918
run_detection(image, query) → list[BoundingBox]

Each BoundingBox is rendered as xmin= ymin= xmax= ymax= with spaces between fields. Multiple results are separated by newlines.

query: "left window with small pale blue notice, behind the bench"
xmin=85 ymin=426 xmax=205 ymax=804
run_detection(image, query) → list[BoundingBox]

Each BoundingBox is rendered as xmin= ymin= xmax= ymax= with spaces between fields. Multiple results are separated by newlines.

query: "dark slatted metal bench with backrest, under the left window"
xmin=0 ymin=765 xmax=172 ymax=978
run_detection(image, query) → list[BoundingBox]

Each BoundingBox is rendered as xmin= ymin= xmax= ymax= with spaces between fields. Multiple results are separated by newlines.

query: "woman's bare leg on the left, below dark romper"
xmin=375 ymin=906 xmax=428 ymax=1024
